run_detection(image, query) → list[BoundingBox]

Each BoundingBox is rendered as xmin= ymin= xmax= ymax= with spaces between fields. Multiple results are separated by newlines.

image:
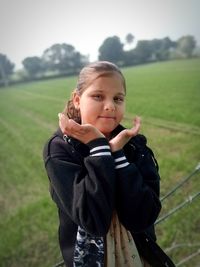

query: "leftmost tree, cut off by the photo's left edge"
xmin=0 ymin=54 xmax=15 ymax=86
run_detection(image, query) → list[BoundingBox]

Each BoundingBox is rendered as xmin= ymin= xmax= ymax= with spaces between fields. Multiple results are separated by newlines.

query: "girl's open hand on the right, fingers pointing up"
xmin=109 ymin=117 xmax=141 ymax=152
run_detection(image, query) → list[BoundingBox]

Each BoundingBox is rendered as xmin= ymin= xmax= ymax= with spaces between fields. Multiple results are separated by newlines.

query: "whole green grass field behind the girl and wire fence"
xmin=0 ymin=59 xmax=200 ymax=267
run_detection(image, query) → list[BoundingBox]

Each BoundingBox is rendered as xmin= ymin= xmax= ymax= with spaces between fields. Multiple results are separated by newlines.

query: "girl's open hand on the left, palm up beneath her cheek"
xmin=58 ymin=113 xmax=105 ymax=144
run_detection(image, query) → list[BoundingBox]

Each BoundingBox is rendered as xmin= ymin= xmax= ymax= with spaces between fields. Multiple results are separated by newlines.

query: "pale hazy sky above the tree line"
xmin=0 ymin=0 xmax=200 ymax=68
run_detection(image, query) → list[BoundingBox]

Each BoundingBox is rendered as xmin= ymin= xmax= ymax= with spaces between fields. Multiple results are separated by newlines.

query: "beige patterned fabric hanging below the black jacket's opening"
xmin=106 ymin=213 xmax=150 ymax=267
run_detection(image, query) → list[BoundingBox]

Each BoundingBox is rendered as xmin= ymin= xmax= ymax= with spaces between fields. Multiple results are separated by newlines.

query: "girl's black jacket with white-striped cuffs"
xmin=43 ymin=126 xmax=174 ymax=267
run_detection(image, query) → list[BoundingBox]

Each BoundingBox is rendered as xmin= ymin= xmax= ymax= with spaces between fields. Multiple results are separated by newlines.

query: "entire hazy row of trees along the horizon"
xmin=0 ymin=33 xmax=199 ymax=86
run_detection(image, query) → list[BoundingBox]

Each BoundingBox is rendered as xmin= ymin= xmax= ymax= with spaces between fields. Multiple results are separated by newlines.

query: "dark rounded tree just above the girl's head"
xmin=99 ymin=36 xmax=124 ymax=65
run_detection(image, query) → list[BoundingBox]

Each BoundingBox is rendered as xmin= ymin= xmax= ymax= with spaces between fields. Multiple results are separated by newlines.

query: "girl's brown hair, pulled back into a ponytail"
xmin=63 ymin=61 xmax=126 ymax=123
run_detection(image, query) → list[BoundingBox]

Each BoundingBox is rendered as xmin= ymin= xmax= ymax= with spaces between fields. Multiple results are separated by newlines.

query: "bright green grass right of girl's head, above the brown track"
xmin=125 ymin=60 xmax=200 ymax=126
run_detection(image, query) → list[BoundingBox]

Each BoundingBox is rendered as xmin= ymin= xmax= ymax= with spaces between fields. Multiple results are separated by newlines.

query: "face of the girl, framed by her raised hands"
xmin=74 ymin=74 xmax=125 ymax=137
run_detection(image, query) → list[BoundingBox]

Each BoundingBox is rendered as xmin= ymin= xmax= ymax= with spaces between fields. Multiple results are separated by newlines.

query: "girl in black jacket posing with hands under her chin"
xmin=44 ymin=61 xmax=174 ymax=267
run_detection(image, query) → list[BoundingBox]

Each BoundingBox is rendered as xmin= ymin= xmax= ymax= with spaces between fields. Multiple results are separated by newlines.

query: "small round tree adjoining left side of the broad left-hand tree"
xmin=22 ymin=57 xmax=44 ymax=78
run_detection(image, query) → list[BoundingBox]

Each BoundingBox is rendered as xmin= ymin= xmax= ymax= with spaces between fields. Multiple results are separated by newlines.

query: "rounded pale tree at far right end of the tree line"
xmin=177 ymin=35 xmax=196 ymax=58
